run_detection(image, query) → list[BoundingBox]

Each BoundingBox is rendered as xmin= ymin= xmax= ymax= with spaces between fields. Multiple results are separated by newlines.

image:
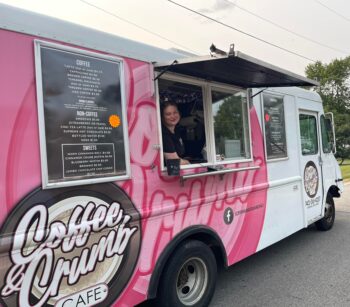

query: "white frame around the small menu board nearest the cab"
xmin=261 ymin=92 xmax=289 ymax=161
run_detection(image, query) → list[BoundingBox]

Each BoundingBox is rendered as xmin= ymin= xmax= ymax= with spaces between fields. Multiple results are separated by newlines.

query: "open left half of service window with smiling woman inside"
xmin=158 ymin=76 xmax=207 ymax=164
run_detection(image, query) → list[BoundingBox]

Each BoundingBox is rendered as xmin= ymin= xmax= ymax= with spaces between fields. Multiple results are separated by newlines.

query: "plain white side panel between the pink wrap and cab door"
xmin=257 ymin=91 xmax=306 ymax=250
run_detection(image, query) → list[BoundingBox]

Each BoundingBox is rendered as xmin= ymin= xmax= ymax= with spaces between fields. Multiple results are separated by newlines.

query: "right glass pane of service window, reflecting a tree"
xmin=211 ymin=88 xmax=250 ymax=161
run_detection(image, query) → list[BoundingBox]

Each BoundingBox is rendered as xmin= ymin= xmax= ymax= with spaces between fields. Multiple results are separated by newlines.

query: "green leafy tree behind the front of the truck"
xmin=305 ymin=57 xmax=350 ymax=161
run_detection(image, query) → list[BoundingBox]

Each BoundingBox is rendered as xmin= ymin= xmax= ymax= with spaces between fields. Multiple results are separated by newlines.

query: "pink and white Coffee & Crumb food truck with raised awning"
xmin=0 ymin=5 xmax=343 ymax=307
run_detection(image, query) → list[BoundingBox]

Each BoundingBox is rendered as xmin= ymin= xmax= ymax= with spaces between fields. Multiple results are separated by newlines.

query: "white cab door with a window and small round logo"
xmin=299 ymin=111 xmax=323 ymax=225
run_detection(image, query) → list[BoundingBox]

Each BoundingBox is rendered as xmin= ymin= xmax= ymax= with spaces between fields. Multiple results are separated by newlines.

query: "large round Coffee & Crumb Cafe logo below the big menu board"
xmin=0 ymin=183 xmax=141 ymax=307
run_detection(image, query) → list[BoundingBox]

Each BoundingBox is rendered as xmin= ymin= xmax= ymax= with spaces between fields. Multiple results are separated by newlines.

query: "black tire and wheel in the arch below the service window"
xmin=157 ymin=240 xmax=217 ymax=307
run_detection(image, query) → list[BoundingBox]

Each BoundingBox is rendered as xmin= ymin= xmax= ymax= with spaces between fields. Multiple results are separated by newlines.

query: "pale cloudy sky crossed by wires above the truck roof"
xmin=0 ymin=0 xmax=350 ymax=76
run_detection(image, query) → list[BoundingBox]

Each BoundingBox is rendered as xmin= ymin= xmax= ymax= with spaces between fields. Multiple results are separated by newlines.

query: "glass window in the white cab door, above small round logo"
xmin=299 ymin=114 xmax=318 ymax=155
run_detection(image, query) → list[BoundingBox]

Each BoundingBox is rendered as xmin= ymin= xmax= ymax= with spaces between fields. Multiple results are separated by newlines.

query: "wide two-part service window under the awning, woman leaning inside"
xmin=158 ymin=74 xmax=251 ymax=168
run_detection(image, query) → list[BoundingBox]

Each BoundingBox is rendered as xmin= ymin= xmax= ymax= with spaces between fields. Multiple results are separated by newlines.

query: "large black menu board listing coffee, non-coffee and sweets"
xmin=37 ymin=44 xmax=127 ymax=185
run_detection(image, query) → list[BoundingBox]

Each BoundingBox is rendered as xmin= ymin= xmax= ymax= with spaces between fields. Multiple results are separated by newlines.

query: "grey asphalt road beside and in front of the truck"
xmin=210 ymin=185 xmax=350 ymax=307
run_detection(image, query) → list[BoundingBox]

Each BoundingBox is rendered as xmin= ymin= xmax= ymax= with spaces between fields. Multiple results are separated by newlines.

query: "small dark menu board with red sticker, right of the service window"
xmin=263 ymin=94 xmax=287 ymax=159
